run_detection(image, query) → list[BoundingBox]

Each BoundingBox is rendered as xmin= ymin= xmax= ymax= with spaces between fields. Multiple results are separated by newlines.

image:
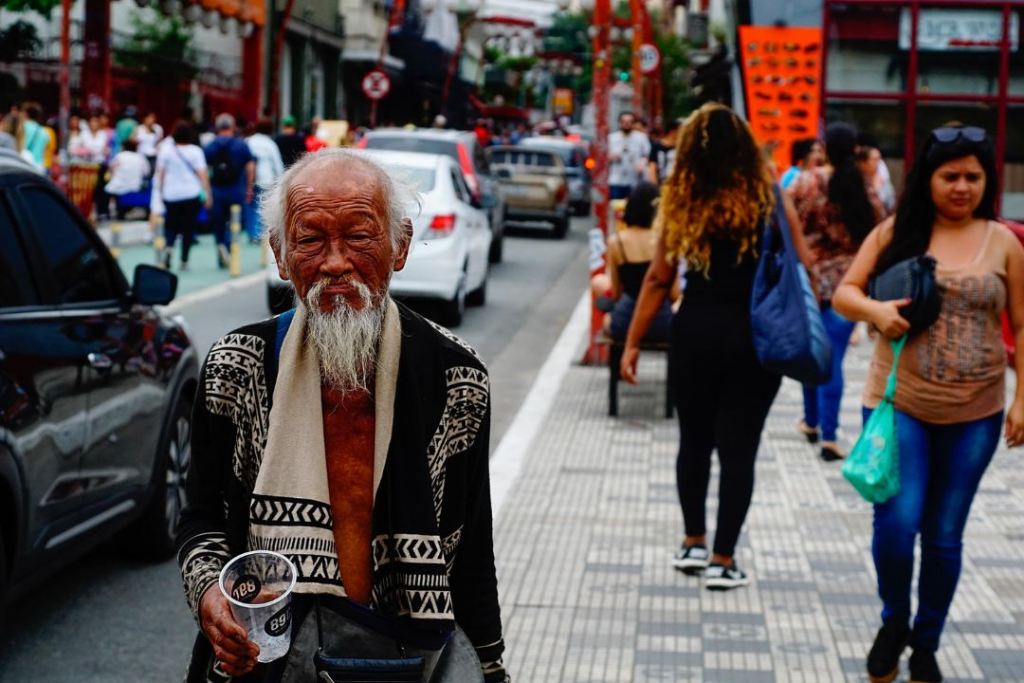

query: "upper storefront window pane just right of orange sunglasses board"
xmin=825 ymin=5 xmax=907 ymax=93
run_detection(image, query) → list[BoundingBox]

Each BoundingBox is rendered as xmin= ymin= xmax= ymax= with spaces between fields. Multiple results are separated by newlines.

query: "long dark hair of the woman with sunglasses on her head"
xmin=874 ymin=126 xmax=999 ymax=272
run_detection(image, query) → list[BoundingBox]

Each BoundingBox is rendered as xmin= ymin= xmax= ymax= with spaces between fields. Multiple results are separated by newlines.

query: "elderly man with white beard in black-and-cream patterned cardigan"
xmin=178 ymin=150 xmax=508 ymax=683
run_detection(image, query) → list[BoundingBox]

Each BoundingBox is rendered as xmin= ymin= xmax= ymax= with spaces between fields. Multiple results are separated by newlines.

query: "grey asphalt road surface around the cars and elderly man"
xmin=0 ymin=219 xmax=592 ymax=683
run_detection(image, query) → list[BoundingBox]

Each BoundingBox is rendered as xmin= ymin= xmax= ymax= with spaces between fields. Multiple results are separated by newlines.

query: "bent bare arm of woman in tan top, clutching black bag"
xmin=833 ymin=219 xmax=910 ymax=339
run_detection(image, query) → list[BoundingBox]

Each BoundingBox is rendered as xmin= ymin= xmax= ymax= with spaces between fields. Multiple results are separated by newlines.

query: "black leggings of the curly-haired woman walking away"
xmin=671 ymin=344 xmax=781 ymax=557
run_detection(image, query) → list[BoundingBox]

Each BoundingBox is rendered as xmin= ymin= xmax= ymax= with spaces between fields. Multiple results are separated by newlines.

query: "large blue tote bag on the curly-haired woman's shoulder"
xmin=751 ymin=186 xmax=831 ymax=384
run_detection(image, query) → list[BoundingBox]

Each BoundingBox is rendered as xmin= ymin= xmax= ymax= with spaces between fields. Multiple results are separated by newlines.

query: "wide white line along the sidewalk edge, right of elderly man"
xmin=490 ymin=292 xmax=591 ymax=519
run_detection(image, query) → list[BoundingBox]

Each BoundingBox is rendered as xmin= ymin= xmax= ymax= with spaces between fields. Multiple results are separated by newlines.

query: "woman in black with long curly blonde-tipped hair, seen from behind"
xmin=622 ymin=104 xmax=807 ymax=590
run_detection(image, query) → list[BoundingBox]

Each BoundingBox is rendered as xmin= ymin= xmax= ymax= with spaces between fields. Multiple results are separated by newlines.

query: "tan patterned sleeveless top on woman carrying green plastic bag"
xmin=864 ymin=221 xmax=1016 ymax=424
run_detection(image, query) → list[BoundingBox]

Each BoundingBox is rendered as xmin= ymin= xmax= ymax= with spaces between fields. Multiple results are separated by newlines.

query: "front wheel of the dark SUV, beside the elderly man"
xmin=128 ymin=396 xmax=191 ymax=560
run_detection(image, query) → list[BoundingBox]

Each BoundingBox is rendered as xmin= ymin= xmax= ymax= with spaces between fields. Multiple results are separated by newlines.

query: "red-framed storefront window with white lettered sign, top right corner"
xmin=913 ymin=7 xmax=1020 ymax=95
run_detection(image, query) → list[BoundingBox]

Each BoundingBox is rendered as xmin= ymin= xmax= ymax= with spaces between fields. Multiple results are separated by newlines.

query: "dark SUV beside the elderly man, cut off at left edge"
xmin=0 ymin=151 xmax=199 ymax=608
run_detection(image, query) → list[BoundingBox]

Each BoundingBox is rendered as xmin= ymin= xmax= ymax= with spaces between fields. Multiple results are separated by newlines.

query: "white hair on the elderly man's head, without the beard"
xmin=259 ymin=147 xmax=420 ymax=258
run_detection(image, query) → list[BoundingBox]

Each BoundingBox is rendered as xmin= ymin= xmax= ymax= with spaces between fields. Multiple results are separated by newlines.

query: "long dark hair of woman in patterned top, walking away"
xmin=825 ymin=123 xmax=876 ymax=245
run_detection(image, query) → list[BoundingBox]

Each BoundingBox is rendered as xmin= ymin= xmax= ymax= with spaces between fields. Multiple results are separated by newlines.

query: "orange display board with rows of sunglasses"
xmin=739 ymin=26 xmax=822 ymax=176
